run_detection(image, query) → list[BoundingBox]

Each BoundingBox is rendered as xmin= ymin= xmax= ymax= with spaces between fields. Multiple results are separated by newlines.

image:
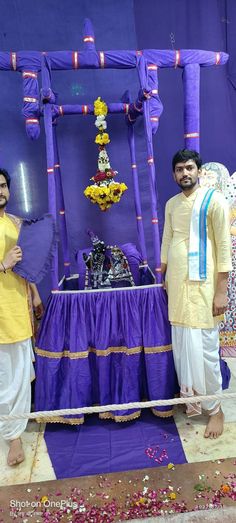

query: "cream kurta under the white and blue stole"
xmin=161 ymin=188 xmax=232 ymax=329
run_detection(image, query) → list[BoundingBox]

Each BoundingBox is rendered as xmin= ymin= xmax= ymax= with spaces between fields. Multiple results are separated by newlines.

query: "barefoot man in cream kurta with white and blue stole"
xmin=161 ymin=149 xmax=232 ymax=438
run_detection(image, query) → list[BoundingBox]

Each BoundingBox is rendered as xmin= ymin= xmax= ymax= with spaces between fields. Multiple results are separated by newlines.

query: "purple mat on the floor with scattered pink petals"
xmin=44 ymin=410 xmax=187 ymax=479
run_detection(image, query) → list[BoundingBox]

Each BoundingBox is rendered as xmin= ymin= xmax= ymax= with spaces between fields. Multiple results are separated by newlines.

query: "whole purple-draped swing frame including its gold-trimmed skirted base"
xmin=0 ymin=19 xmax=228 ymax=424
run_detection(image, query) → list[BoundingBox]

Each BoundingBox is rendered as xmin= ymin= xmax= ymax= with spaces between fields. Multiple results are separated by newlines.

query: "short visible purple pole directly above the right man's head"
xmin=183 ymin=64 xmax=200 ymax=152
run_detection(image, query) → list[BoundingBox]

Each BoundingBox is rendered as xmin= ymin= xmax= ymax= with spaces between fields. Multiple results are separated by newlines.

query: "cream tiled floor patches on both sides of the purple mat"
xmin=0 ymin=358 xmax=236 ymax=486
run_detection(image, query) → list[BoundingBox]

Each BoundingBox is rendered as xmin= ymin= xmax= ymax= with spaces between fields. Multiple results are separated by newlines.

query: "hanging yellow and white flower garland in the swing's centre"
xmin=84 ymin=96 xmax=128 ymax=211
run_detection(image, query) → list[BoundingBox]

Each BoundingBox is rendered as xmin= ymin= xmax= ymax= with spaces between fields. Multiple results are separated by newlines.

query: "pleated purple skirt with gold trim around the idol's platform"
xmin=35 ymin=286 xmax=178 ymax=422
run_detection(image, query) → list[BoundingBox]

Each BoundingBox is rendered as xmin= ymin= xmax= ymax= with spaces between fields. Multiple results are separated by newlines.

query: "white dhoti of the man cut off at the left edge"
xmin=0 ymin=338 xmax=35 ymax=440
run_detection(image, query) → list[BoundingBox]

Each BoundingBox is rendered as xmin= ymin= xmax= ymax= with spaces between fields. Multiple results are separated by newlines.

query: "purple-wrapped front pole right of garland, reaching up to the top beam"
xmin=138 ymin=56 xmax=161 ymax=283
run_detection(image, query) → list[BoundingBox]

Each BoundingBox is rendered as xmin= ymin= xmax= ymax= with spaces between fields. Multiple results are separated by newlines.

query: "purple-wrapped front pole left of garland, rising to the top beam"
xmin=42 ymin=55 xmax=59 ymax=290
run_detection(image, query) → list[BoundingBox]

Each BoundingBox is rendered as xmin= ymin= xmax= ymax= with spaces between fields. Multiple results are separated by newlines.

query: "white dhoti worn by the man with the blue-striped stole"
xmin=172 ymin=325 xmax=222 ymax=416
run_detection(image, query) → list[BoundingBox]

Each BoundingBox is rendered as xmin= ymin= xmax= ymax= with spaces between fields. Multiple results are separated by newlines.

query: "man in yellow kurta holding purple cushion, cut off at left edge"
xmin=0 ymin=169 xmax=40 ymax=465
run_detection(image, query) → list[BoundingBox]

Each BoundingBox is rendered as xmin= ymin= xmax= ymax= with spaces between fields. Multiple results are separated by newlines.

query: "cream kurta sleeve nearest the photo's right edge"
xmin=211 ymin=192 xmax=232 ymax=272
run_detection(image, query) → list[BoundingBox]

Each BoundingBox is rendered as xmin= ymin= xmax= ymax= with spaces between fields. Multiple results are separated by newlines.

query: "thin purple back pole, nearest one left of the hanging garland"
xmin=53 ymin=125 xmax=70 ymax=278
